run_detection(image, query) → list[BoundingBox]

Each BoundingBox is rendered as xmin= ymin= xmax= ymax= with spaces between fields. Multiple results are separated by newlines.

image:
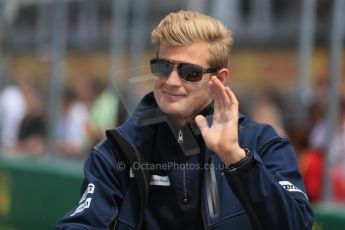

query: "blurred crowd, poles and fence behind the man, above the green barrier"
xmin=0 ymin=0 xmax=345 ymax=228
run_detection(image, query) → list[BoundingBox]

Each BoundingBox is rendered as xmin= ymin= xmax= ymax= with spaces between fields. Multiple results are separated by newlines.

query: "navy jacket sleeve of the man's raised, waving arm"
xmin=225 ymin=126 xmax=313 ymax=230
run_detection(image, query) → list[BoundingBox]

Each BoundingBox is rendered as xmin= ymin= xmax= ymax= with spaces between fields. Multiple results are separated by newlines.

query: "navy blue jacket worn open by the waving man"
xmin=56 ymin=93 xmax=313 ymax=230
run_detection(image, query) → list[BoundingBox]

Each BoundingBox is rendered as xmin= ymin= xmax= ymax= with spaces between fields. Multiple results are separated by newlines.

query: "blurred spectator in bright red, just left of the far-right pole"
xmin=295 ymin=84 xmax=327 ymax=202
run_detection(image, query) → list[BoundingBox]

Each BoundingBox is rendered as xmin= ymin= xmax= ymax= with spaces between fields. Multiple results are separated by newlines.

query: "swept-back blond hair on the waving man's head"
xmin=151 ymin=10 xmax=233 ymax=68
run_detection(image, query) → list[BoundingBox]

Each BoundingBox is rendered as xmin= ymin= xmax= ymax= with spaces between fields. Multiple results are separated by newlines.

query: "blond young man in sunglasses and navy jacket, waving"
xmin=57 ymin=11 xmax=313 ymax=230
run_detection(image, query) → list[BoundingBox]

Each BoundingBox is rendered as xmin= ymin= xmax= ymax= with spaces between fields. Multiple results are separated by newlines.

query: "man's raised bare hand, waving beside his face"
xmin=195 ymin=76 xmax=246 ymax=164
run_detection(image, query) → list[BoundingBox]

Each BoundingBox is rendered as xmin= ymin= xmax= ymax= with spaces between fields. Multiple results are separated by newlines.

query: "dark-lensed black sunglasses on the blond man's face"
xmin=150 ymin=58 xmax=218 ymax=82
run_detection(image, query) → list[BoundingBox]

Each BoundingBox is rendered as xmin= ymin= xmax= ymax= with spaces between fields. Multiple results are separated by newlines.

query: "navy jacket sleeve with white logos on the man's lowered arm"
xmin=56 ymin=140 xmax=124 ymax=230
